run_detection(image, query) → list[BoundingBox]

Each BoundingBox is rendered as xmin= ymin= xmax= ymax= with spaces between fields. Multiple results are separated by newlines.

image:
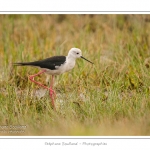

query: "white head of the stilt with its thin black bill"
xmin=68 ymin=48 xmax=93 ymax=64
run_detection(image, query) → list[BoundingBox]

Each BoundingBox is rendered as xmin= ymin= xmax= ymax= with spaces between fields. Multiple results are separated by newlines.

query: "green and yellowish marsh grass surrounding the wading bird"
xmin=0 ymin=15 xmax=150 ymax=135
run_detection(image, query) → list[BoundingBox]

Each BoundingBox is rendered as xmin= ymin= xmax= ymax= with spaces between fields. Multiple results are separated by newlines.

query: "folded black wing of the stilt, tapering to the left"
xmin=14 ymin=56 xmax=66 ymax=70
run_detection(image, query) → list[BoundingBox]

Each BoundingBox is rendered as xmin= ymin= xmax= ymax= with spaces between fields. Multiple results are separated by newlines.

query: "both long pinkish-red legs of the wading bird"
xmin=29 ymin=70 xmax=55 ymax=108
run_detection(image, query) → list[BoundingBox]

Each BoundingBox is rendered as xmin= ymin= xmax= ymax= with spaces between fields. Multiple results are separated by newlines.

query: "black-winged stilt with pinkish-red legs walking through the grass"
xmin=14 ymin=48 xmax=93 ymax=108
